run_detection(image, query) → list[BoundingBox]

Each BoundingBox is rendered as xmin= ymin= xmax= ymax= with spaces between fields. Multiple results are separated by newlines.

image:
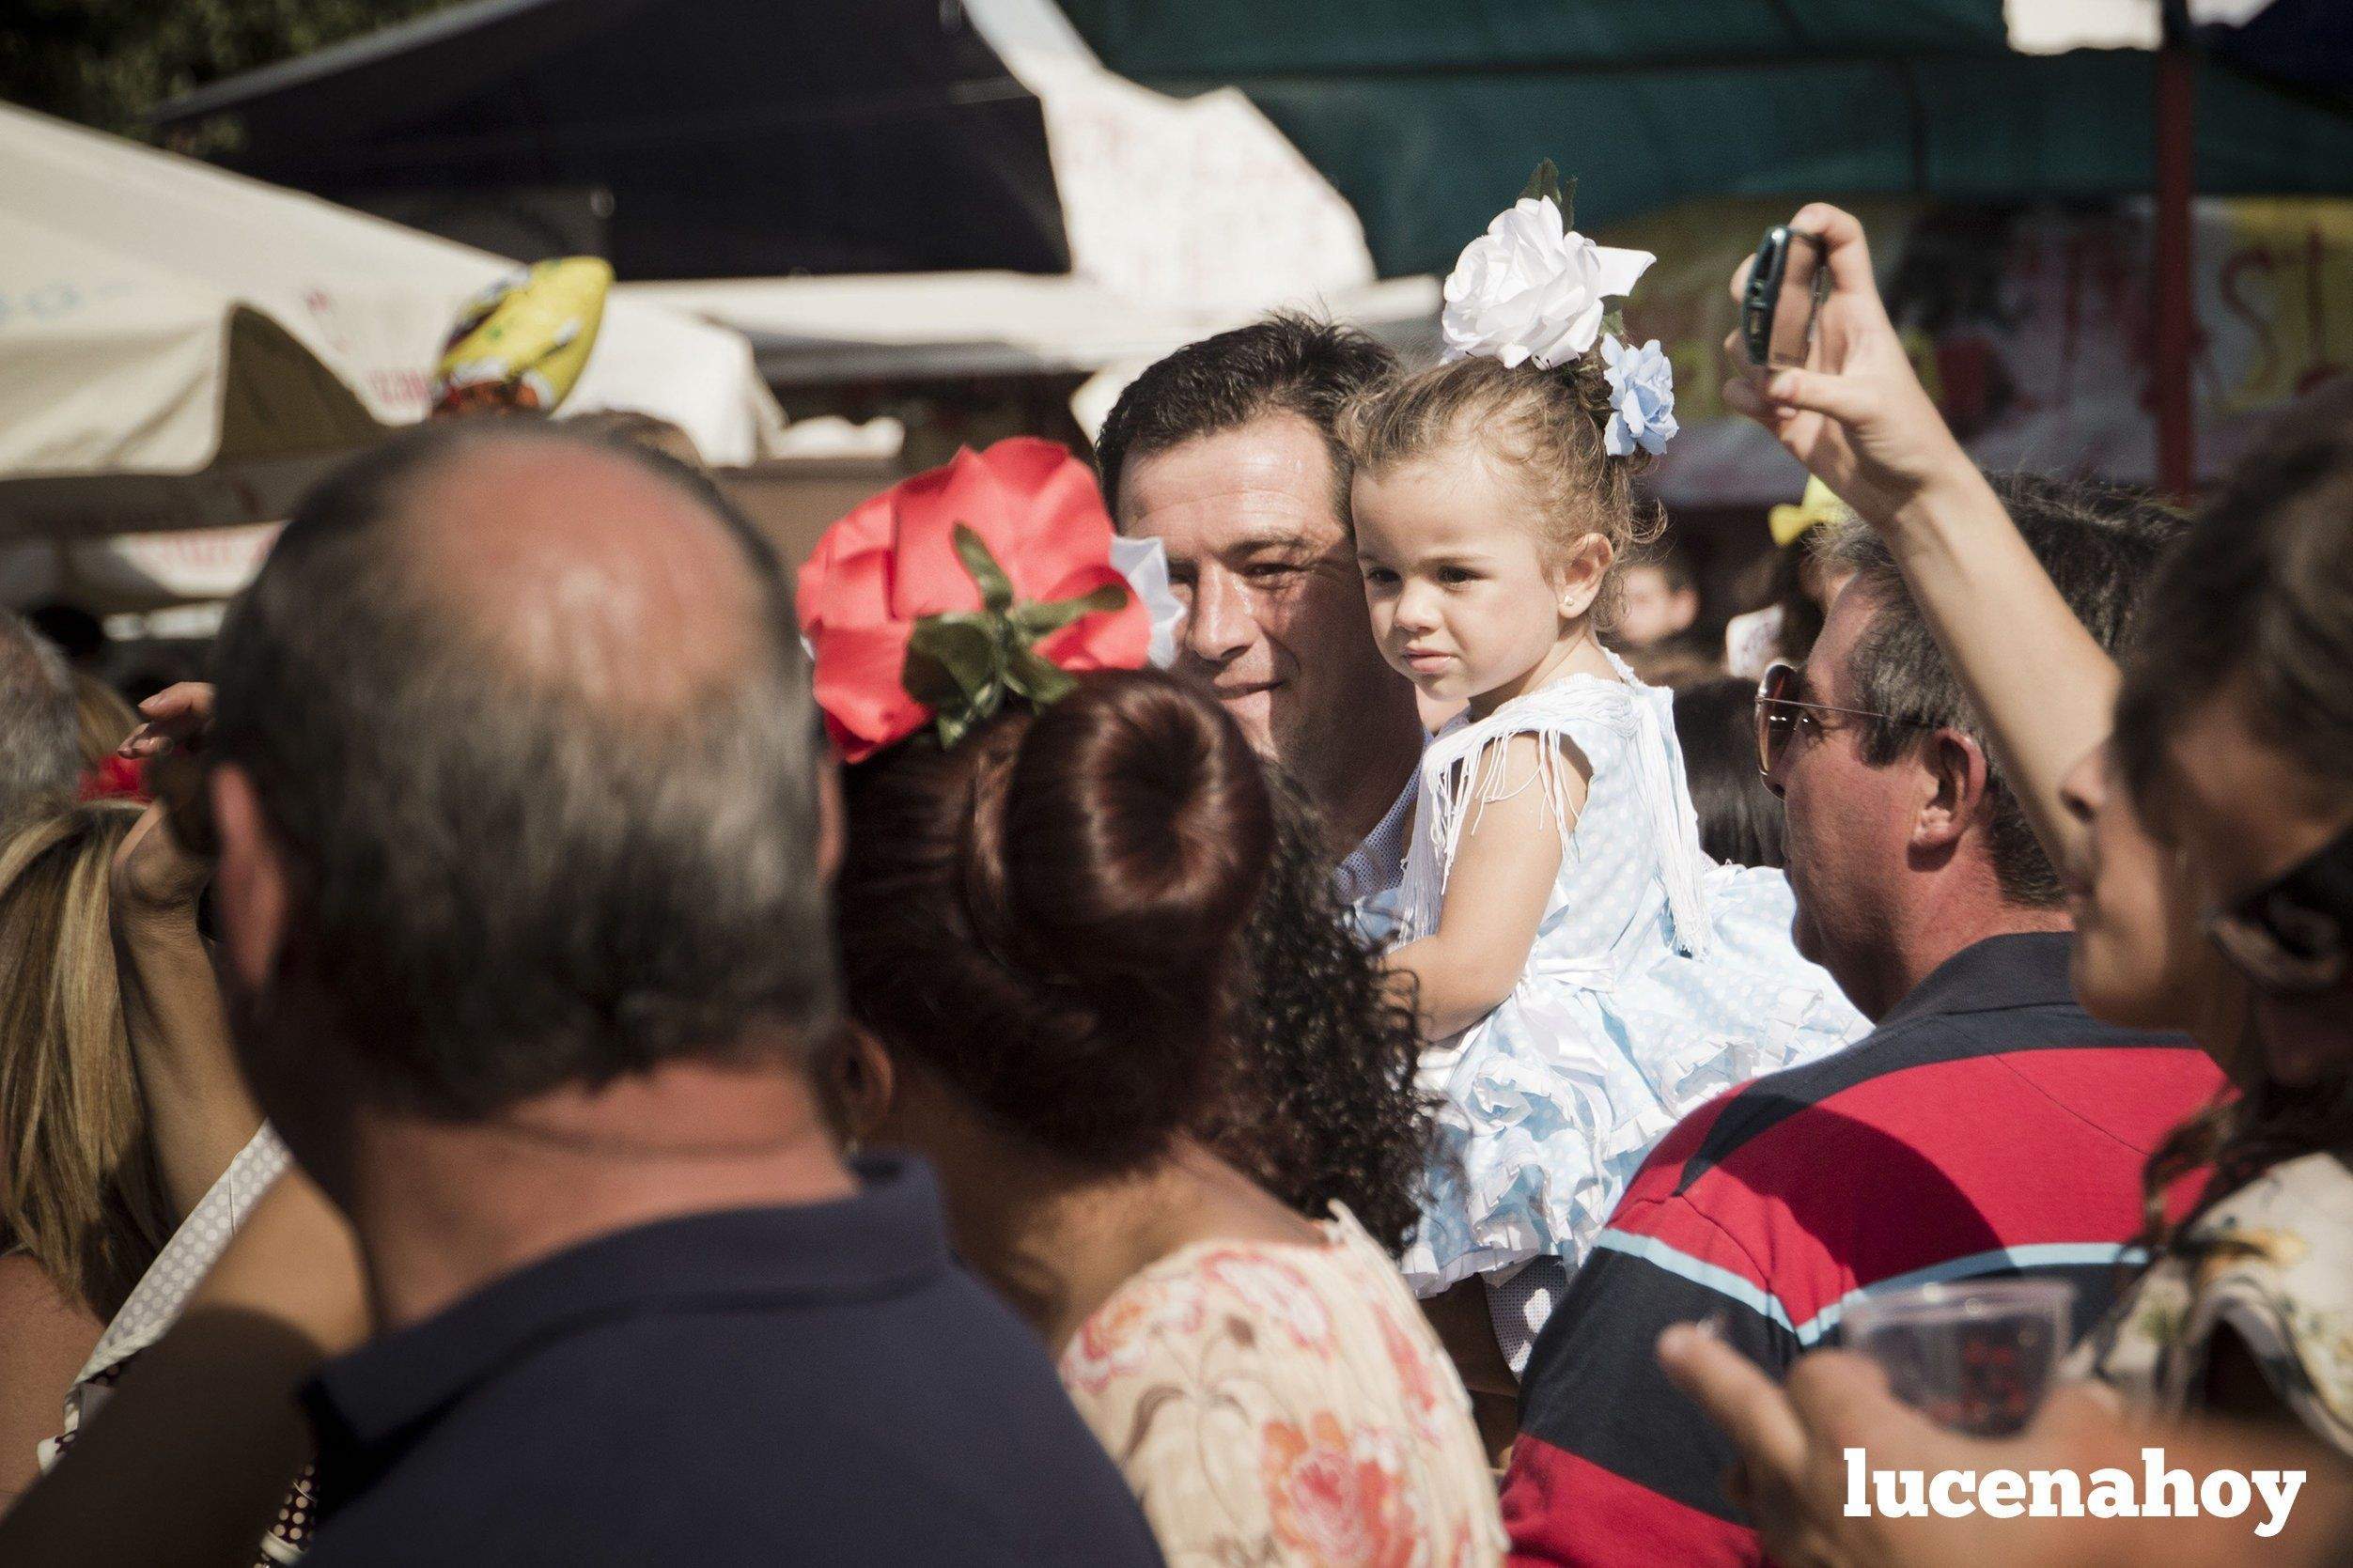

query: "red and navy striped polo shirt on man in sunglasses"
xmin=1504 ymin=933 xmax=2221 ymax=1563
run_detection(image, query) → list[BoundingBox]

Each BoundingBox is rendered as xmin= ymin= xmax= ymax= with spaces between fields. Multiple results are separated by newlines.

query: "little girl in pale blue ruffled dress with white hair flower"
xmin=1346 ymin=186 xmax=1863 ymax=1373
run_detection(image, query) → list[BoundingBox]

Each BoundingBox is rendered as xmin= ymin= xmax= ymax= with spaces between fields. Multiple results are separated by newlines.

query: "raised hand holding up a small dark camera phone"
xmin=1724 ymin=202 xmax=1981 ymax=529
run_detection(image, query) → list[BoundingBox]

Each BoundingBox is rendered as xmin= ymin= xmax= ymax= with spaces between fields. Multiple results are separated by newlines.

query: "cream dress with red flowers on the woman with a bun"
xmin=1061 ymin=1203 xmax=1504 ymax=1568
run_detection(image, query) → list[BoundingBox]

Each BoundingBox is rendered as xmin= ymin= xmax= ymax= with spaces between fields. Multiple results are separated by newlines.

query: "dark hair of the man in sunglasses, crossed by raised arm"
xmin=1824 ymin=474 xmax=2186 ymax=908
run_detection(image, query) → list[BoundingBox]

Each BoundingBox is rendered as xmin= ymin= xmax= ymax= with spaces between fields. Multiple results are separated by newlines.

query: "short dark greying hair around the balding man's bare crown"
xmin=210 ymin=421 xmax=835 ymax=1119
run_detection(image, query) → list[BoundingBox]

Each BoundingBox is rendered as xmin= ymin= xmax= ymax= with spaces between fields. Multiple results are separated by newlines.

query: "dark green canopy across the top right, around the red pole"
xmin=1061 ymin=0 xmax=2353 ymax=275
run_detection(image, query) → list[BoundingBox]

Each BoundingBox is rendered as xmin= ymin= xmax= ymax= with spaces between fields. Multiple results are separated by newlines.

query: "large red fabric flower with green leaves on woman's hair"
xmin=798 ymin=437 xmax=1150 ymax=762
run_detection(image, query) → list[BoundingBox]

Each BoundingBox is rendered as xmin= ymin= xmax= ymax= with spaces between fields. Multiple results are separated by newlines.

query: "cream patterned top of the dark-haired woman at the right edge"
xmin=2066 ymin=1155 xmax=2353 ymax=1452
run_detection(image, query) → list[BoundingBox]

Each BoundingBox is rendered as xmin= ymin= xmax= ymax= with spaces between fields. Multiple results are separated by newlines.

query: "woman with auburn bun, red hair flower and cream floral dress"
xmin=800 ymin=442 xmax=1502 ymax=1565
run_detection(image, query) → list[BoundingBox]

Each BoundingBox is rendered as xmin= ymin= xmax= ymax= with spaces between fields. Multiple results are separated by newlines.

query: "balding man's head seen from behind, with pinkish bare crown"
xmin=214 ymin=421 xmax=833 ymax=1117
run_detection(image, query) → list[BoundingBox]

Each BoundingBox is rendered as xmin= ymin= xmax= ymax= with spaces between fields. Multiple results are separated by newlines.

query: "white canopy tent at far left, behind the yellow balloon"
xmin=0 ymin=95 xmax=784 ymax=562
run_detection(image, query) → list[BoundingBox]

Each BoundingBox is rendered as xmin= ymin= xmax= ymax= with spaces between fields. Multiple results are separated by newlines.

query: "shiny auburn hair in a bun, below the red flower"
xmin=842 ymin=670 xmax=1273 ymax=1166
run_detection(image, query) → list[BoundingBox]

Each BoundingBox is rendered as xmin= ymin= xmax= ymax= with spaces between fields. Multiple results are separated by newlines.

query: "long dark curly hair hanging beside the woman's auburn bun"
xmin=1195 ymin=776 xmax=1433 ymax=1253
